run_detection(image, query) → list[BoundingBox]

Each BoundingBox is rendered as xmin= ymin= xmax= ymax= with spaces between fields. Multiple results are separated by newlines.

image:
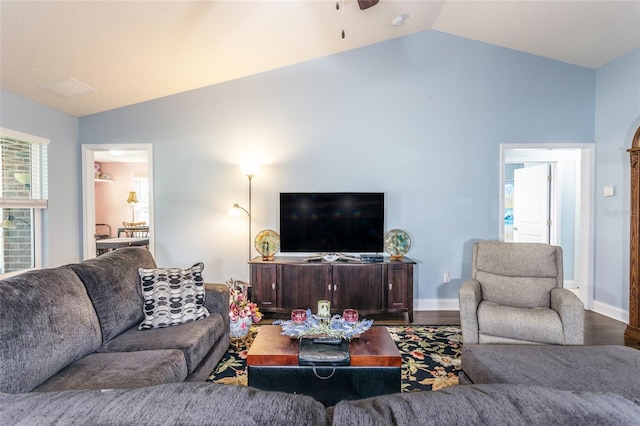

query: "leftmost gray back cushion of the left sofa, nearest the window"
xmin=0 ymin=267 xmax=102 ymax=392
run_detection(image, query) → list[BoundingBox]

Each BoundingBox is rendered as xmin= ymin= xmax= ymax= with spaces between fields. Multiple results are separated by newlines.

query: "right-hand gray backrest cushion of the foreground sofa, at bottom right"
xmin=329 ymin=385 xmax=640 ymax=426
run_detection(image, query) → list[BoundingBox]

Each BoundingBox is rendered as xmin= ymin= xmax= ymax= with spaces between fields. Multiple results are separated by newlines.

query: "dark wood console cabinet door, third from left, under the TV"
xmin=331 ymin=264 xmax=384 ymax=313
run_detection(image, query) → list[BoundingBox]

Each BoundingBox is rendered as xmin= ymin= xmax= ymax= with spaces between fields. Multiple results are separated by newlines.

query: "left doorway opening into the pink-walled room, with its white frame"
xmin=82 ymin=144 xmax=155 ymax=259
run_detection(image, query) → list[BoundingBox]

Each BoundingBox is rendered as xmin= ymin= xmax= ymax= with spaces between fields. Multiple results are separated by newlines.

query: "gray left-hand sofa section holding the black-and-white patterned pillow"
xmin=0 ymin=247 xmax=229 ymax=393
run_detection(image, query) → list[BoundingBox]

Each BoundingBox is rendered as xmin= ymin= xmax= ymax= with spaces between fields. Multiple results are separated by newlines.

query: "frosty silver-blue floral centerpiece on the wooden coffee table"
xmin=273 ymin=309 xmax=373 ymax=340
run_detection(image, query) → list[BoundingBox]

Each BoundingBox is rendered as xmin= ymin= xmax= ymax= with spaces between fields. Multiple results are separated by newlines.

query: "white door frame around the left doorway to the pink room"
xmin=81 ymin=143 xmax=155 ymax=260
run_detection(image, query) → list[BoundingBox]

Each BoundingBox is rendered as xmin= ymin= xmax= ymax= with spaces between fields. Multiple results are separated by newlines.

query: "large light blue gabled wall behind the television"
xmin=80 ymin=31 xmax=596 ymax=306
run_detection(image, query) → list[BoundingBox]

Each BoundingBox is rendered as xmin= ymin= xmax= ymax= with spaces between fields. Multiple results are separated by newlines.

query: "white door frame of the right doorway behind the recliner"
xmin=498 ymin=143 xmax=595 ymax=310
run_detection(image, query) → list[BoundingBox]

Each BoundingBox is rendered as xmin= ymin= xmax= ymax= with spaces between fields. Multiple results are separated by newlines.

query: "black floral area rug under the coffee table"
xmin=207 ymin=325 xmax=462 ymax=392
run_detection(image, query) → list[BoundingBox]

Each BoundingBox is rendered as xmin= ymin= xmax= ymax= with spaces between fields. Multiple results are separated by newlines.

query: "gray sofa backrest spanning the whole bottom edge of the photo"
xmin=0 ymin=383 xmax=640 ymax=426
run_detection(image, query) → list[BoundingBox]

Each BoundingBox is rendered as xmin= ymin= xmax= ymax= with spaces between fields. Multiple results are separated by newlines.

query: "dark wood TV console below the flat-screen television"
xmin=249 ymin=256 xmax=416 ymax=322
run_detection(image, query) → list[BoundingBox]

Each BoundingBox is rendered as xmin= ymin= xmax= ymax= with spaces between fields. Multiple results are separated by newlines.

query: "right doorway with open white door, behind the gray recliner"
xmin=499 ymin=144 xmax=595 ymax=309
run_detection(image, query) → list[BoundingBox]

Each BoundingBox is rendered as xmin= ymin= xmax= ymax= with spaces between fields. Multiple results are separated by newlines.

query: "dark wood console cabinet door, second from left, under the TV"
xmin=279 ymin=264 xmax=331 ymax=313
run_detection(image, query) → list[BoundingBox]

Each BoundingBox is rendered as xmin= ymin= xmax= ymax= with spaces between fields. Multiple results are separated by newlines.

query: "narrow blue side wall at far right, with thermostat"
xmin=594 ymin=49 xmax=640 ymax=311
